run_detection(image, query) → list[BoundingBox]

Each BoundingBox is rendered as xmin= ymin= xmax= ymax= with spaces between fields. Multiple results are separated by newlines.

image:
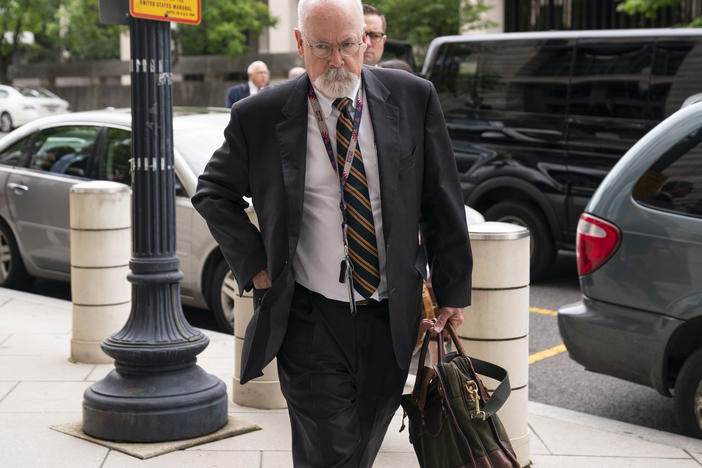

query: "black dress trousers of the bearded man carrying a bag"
xmin=278 ymin=285 xmax=407 ymax=468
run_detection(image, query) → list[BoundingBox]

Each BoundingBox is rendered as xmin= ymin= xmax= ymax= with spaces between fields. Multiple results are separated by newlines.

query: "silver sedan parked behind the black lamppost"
xmin=0 ymin=109 xmax=245 ymax=332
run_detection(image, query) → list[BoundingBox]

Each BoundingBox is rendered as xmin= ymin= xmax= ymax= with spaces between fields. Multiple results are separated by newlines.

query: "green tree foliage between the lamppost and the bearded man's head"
xmin=174 ymin=0 xmax=277 ymax=56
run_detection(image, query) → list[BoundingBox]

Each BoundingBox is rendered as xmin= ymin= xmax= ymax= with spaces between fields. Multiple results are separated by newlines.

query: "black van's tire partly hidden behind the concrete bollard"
xmin=485 ymin=200 xmax=556 ymax=282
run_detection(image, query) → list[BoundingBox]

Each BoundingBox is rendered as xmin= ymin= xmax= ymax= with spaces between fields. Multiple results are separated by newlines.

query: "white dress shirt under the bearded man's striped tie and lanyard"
xmin=293 ymin=81 xmax=387 ymax=302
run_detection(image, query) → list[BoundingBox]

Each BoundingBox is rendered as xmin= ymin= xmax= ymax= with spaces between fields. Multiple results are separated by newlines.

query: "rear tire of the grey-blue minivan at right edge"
xmin=674 ymin=349 xmax=702 ymax=439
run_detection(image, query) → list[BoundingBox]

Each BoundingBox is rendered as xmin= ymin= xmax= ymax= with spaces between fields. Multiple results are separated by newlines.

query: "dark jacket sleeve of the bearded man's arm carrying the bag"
xmin=420 ymin=84 xmax=473 ymax=307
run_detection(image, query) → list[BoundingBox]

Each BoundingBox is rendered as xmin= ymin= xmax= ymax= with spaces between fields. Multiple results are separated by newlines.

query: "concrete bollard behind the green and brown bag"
xmin=458 ymin=222 xmax=530 ymax=466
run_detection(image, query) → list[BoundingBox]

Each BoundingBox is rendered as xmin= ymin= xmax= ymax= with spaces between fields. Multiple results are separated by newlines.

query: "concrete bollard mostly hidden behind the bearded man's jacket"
xmin=230 ymin=207 xmax=288 ymax=409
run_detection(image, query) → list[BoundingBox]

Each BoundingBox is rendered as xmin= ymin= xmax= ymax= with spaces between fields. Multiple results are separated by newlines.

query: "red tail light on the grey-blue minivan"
xmin=575 ymin=213 xmax=622 ymax=275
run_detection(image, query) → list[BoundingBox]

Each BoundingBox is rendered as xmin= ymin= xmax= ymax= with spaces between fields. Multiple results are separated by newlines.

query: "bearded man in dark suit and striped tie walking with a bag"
xmin=193 ymin=0 xmax=472 ymax=468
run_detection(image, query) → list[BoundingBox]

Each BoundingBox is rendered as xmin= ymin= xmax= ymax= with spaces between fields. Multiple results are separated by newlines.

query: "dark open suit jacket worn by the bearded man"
xmin=193 ymin=67 xmax=472 ymax=383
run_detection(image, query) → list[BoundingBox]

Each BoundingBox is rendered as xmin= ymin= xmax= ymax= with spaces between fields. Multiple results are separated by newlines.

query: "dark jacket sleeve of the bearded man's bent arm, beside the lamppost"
xmin=192 ymin=108 xmax=266 ymax=294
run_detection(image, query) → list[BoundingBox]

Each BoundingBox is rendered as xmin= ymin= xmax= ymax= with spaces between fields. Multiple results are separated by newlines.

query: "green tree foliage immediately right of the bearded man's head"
xmin=373 ymin=0 xmax=492 ymax=51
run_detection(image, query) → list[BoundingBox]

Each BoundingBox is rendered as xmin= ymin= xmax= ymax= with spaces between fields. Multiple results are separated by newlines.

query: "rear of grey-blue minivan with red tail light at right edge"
xmin=558 ymin=102 xmax=702 ymax=438
